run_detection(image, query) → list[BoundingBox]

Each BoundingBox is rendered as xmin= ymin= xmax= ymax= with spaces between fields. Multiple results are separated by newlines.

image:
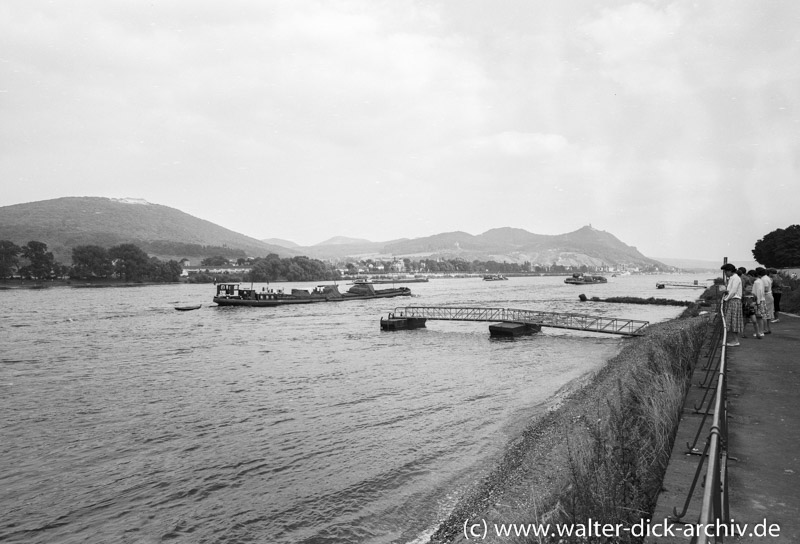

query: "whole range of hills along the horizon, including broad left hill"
xmin=0 ymin=197 xmax=669 ymax=269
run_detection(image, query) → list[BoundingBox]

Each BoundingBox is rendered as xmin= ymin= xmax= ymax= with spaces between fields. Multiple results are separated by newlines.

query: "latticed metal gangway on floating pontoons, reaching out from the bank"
xmin=381 ymin=306 xmax=649 ymax=336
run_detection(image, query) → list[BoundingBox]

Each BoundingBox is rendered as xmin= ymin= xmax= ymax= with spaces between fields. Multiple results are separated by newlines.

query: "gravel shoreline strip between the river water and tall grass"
xmin=427 ymin=317 xmax=706 ymax=544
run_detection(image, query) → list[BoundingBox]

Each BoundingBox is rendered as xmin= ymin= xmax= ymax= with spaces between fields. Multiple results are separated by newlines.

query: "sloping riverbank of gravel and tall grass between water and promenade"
xmin=430 ymin=314 xmax=708 ymax=544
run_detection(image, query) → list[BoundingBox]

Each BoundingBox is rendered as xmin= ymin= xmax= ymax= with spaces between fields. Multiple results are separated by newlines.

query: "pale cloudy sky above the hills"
xmin=0 ymin=0 xmax=800 ymax=262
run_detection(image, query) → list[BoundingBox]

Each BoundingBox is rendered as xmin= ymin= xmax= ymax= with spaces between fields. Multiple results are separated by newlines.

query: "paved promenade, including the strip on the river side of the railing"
xmin=646 ymin=314 xmax=800 ymax=544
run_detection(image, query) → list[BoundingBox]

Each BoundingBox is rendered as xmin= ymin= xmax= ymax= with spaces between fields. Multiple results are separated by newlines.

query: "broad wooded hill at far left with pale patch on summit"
xmin=0 ymin=197 xmax=299 ymax=263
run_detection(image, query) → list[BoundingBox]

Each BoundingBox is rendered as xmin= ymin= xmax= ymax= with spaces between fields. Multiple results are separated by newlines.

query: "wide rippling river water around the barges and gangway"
xmin=0 ymin=275 xmax=706 ymax=544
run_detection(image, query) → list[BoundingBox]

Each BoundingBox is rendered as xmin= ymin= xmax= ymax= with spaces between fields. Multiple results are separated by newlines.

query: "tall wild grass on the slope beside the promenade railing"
xmin=550 ymin=318 xmax=709 ymax=542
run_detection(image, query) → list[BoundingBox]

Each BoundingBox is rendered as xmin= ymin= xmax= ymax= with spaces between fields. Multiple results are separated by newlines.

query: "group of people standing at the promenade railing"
xmin=721 ymin=263 xmax=783 ymax=347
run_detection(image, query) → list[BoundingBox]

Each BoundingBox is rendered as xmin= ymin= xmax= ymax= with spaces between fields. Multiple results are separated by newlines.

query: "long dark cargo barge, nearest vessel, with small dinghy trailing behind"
xmin=213 ymin=282 xmax=411 ymax=307
